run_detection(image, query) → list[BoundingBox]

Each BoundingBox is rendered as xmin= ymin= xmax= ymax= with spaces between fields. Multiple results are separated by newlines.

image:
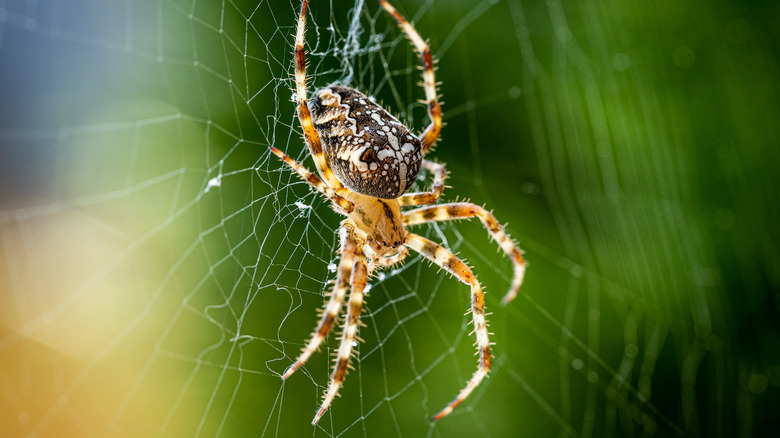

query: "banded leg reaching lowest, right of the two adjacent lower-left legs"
xmin=311 ymin=242 xmax=368 ymax=424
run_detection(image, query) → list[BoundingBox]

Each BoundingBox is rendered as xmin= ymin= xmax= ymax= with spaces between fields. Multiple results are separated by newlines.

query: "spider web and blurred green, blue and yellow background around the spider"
xmin=0 ymin=0 xmax=780 ymax=437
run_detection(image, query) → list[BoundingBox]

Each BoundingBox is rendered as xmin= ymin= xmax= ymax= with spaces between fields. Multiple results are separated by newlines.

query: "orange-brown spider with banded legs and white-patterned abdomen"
xmin=271 ymin=0 xmax=525 ymax=425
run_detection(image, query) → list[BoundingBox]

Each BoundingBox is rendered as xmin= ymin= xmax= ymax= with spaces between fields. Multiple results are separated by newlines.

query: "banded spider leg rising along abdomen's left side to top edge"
xmin=293 ymin=0 xmax=342 ymax=189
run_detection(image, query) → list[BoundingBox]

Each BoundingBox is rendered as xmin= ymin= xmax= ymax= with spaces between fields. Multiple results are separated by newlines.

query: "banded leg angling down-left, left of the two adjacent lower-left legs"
xmin=282 ymin=219 xmax=358 ymax=380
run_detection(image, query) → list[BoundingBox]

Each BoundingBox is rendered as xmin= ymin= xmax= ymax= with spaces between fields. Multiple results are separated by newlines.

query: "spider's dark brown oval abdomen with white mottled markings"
xmin=309 ymin=85 xmax=422 ymax=199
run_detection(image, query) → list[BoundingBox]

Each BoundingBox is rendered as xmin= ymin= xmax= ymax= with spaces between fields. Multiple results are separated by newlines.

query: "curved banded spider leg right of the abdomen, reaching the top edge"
xmin=379 ymin=0 xmax=441 ymax=155
